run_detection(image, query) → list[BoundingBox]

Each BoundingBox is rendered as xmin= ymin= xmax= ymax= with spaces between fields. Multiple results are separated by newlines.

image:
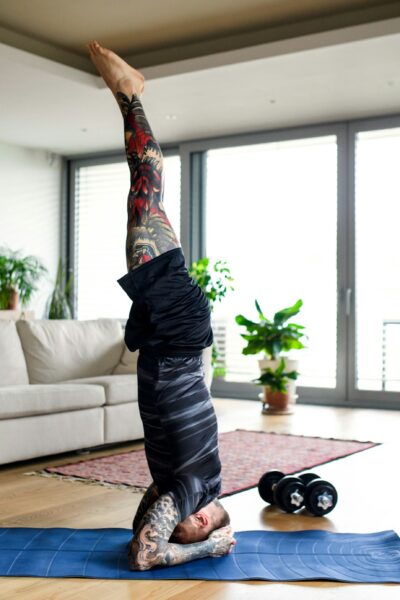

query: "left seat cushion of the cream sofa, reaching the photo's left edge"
xmin=0 ymin=384 xmax=105 ymax=419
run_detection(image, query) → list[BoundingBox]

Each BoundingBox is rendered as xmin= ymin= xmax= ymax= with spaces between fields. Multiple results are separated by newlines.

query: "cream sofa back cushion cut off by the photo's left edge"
xmin=0 ymin=319 xmax=29 ymax=386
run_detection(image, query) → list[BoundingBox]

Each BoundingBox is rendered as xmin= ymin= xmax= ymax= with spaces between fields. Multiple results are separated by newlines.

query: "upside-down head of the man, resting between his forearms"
xmin=170 ymin=499 xmax=230 ymax=544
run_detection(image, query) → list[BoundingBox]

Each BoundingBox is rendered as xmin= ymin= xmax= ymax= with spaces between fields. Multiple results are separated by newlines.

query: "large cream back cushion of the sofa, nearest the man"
xmin=17 ymin=319 xmax=124 ymax=383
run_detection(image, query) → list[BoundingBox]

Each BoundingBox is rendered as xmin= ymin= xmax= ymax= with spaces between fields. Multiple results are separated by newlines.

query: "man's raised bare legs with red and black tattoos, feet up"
xmin=87 ymin=40 xmax=180 ymax=270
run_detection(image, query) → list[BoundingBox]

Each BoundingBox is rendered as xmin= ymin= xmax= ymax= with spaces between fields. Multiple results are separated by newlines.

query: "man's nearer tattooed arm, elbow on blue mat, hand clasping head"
xmin=129 ymin=494 xmax=235 ymax=571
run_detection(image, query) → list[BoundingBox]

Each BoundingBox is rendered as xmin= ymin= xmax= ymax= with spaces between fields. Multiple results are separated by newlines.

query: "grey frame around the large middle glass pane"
xmin=179 ymin=123 xmax=349 ymax=405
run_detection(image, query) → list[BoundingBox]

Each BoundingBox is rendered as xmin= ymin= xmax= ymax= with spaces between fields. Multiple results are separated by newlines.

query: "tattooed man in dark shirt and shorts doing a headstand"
xmin=87 ymin=41 xmax=236 ymax=570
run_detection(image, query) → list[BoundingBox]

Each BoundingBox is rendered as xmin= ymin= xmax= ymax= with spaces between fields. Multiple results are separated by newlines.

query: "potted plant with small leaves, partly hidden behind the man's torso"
xmin=188 ymin=257 xmax=234 ymax=387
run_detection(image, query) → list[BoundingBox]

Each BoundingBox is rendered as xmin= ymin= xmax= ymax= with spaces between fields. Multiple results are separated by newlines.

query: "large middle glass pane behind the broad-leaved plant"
xmin=206 ymin=136 xmax=337 ymax=388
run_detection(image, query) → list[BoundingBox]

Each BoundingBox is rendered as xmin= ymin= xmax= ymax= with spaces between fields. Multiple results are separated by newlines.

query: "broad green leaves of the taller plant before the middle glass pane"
xmin=235 ymin=300 xmax=308 ymax=359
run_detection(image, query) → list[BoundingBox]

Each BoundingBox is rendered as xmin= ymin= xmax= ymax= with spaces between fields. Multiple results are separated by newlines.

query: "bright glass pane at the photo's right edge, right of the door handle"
xmin=355 ymin=128 xmax=400 ymax=391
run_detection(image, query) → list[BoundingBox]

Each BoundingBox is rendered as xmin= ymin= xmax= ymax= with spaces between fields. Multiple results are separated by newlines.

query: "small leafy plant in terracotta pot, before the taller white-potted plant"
xmin=253 ymin=357 xmax=299 ymax=414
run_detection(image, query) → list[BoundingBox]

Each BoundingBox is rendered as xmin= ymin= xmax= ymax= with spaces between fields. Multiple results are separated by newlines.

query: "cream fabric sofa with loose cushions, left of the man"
xmin=0 ymin=318 xmax=212 ymax=464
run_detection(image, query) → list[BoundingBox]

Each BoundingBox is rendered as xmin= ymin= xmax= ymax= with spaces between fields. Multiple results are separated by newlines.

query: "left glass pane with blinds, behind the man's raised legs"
xmin=75 ymin=156 xmax=181 ymax=319
